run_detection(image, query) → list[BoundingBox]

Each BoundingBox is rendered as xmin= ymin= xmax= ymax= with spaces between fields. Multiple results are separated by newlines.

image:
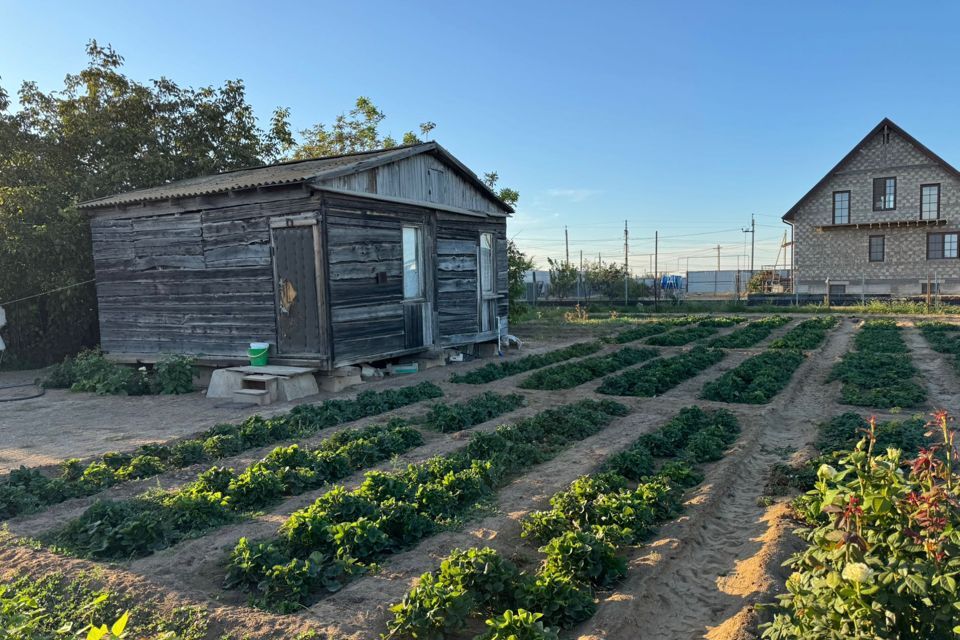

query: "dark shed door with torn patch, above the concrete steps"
xmin=272 ymin=220 xmax=322 ymax=354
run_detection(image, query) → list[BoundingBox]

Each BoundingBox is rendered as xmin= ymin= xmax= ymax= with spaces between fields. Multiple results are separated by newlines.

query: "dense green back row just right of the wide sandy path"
xmin=827 ymin=320 xmax=927 ymax=408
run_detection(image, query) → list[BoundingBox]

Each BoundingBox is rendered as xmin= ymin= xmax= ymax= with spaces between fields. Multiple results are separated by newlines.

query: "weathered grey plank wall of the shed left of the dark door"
xmin=91 ymin=189 xmax=319 ymax=358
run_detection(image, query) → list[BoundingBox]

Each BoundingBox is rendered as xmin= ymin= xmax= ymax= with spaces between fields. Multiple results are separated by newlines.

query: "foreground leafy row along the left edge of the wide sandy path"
xmin=388 ymin=407 xmax=740 ymax=640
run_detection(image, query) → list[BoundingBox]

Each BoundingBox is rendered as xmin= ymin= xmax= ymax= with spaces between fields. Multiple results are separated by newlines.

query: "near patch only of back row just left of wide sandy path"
xmin=701 ymin=349 xmax=804 ymax=404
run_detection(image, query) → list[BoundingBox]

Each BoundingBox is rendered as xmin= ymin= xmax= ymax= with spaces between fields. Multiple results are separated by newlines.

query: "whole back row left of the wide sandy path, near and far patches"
xmin=701 ymin=317 xmax=837 ymax=404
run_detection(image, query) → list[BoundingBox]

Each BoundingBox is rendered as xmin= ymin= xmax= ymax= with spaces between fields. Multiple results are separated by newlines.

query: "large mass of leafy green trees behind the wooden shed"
xmin=0 ymin=41 xmax=519 ymax=365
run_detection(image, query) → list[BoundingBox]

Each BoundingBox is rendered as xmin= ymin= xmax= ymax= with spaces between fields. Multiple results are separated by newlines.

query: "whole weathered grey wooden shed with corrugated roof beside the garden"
xmin=80 ymin=142 xmax=513 ymax=370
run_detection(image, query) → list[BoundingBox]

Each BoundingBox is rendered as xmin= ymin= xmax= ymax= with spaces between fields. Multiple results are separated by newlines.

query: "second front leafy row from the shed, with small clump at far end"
xmin=47 ymin=392 xmax=524 ymax=559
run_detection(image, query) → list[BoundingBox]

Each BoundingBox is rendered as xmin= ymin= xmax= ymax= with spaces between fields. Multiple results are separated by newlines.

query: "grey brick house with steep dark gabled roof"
xmin=783 ymin=118 xmax=960 ymax=296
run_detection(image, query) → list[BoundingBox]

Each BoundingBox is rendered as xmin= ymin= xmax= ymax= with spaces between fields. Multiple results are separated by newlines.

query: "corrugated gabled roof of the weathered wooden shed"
xmin=77 ymin=142 xmax=513 ymax=213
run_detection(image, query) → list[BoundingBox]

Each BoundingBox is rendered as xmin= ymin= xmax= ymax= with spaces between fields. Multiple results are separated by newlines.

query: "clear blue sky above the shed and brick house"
xmin=0 ymin=0 xmax=960 ymax=273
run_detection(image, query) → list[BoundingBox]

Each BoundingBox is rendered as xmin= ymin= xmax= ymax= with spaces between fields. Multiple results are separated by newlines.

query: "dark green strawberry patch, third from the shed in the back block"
xmin=597 ymin=347 xmax=726 ymax=397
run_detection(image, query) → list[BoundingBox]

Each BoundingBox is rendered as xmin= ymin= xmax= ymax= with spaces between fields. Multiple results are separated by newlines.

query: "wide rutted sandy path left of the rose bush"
xmin=574 ymin=322 xmax=853 ymax=640
